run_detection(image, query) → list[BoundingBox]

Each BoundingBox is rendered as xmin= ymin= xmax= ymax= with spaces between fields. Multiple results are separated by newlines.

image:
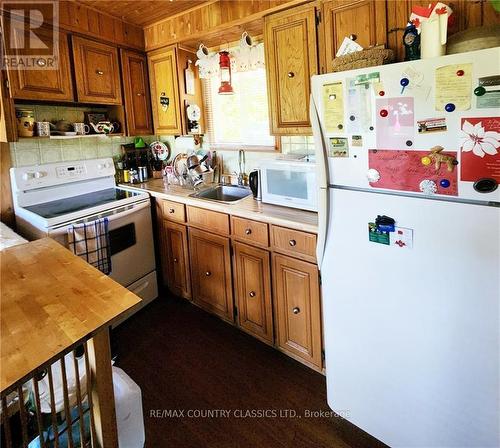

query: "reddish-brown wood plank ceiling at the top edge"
xmin=75 ymin=0 xmax=211 ymax=27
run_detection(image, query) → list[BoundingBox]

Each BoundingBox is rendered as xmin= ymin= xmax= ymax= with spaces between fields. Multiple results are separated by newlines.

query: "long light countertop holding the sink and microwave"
xmin=120 ymin=179 xmax=318 ymax=233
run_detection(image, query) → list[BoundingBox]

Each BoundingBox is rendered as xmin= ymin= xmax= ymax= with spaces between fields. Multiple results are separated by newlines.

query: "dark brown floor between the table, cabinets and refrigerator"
xmin=112 ymin=297 xmax=385 ymax=448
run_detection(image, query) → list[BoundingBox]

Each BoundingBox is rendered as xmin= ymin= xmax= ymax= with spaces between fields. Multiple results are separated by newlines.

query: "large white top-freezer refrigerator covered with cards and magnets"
xmin=310 ymin=48 xmax=500 ymax=448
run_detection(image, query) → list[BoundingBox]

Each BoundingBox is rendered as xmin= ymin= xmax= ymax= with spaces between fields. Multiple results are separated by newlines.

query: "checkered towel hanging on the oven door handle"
xmin=68 ymin=218 xmax=111 ymax=275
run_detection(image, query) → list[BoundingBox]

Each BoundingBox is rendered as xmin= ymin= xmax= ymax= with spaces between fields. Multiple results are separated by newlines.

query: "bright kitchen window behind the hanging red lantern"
xmin=203 ymin=68 xmax=276 ymax=150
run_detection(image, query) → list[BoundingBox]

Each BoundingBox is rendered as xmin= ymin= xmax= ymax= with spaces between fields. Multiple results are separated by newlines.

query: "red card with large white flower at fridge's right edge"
xmin=460 ymin=117 xmax=500 ymax=182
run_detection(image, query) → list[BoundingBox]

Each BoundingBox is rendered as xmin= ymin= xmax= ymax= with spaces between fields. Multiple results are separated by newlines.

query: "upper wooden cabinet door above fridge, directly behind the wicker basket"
xmin=323 ymin=0 xmax=388 ymax=73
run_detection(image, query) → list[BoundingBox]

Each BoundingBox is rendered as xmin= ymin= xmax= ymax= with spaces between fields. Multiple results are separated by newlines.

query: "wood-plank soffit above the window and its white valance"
xmin=144 ymin=0 xmax=305 ymax=51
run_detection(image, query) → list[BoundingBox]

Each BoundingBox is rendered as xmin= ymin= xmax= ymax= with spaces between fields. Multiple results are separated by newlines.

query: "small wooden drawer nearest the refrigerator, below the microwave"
xmin=271 ymin=226 xmax=316 ymax=262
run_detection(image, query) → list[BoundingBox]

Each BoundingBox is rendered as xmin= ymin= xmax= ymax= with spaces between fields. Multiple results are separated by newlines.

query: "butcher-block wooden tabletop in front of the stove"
xmin=0 ymin=238 xmax=141 ymax=391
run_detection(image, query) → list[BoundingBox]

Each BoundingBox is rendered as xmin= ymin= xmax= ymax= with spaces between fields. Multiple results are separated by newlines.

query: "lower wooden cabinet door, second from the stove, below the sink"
xmin=189 ymin=228 xmax=234 ymax=322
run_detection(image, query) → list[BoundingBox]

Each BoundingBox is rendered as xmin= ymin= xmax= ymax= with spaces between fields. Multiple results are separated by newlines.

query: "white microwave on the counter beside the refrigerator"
xmin=260 ymin=159 xmax=318 ymax=211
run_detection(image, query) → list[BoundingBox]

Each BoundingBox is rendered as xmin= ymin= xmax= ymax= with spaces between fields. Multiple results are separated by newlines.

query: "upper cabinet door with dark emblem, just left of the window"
xmin=148 ymin=47 xmax=182 ymax=135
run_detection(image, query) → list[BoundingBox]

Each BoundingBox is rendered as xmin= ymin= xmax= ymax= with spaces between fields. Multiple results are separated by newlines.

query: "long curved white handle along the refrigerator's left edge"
xmin=309 ymin=94 xmax=329 ymax=270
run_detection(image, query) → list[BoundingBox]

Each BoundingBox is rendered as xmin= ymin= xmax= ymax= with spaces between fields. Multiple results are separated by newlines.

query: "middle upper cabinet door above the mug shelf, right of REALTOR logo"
xmin=73 ymin=36 xmax=122 ymax=104
